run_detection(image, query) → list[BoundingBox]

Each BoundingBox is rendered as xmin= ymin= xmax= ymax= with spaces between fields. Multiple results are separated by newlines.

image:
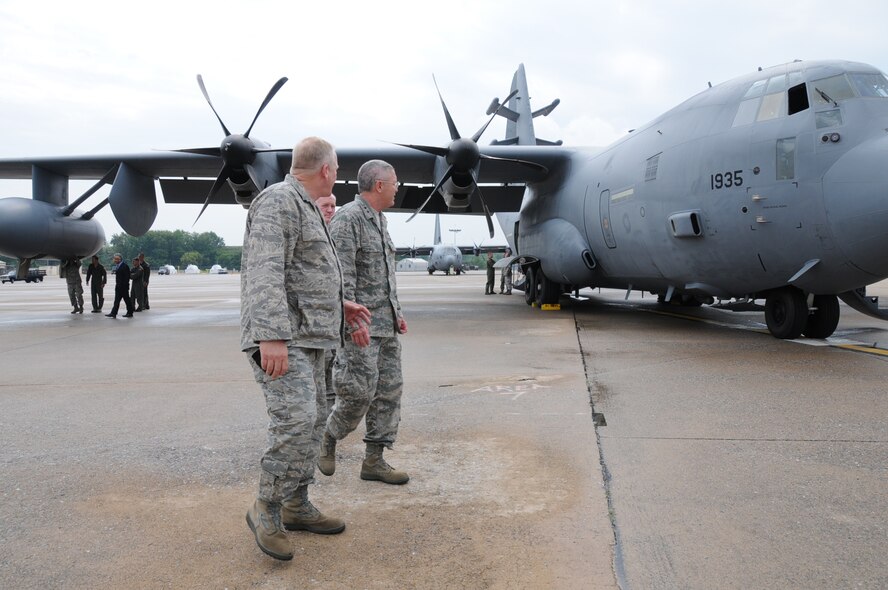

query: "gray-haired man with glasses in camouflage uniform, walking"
xmin=318 ymin=160 xmax=410 ymax=484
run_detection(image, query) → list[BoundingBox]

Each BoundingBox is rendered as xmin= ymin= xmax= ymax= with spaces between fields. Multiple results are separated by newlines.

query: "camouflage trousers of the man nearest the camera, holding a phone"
xmin=249 ymin=347 xmax=326 ymax=504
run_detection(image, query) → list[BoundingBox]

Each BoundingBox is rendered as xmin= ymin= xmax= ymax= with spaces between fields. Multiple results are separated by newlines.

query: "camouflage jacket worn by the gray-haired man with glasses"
xmin=330 ymin=195 xmax=401 ymax=336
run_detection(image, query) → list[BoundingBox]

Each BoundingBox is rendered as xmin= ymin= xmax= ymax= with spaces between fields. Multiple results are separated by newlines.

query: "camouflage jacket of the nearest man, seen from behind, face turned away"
xmin=241 ymin=174 xmax=343 ymax=351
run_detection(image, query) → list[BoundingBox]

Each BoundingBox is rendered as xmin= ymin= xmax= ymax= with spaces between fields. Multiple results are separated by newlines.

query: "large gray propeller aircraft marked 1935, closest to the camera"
xmin=0 ymin=60 xmax=888 ymax=338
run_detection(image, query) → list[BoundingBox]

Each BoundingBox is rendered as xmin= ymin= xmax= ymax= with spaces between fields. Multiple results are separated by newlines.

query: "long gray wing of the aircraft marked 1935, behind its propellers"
xmin=0 ymin=145 xmax=574 ymax=214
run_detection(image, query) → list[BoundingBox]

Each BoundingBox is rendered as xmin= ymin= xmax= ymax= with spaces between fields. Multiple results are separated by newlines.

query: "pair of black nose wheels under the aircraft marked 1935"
xmin=765 ymin=287 xmax=839 ymax=340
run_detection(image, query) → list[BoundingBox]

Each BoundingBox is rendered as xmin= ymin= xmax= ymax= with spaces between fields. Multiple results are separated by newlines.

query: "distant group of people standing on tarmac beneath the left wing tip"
xmin=59 ymin=252 xmax=151 ymax=318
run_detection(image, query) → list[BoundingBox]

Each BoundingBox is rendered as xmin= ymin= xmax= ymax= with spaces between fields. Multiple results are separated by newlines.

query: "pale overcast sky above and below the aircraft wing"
xmin=0 ymin=0 xmax=888 ymax=245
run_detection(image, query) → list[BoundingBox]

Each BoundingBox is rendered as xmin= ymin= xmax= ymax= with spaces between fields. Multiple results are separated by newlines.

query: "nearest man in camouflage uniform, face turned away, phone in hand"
xmin=241 ymin=137 xmax=370 ymax=560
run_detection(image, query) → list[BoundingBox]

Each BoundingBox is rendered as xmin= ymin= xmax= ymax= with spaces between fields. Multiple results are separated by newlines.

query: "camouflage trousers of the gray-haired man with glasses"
xmin=327 ymin=336 xmax=404 ymax=448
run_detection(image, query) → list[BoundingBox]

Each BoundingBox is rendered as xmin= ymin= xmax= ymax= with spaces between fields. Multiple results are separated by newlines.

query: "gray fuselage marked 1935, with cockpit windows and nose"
xmin=517 ymin=62 xmax=888 ymax=306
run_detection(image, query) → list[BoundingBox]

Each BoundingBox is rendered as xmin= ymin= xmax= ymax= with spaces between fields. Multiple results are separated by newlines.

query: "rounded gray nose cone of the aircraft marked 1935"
xmin=823 ymin=136 xmax=888 ymax=278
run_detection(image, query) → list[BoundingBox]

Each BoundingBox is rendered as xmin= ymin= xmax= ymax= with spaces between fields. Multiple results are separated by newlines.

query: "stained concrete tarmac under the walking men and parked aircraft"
xmin=0 ymin=273 xmax=888 ymax=589
